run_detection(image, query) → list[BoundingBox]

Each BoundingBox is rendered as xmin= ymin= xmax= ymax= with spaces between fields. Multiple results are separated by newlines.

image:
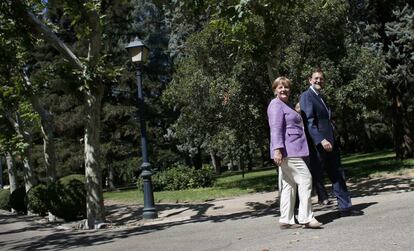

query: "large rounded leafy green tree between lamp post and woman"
xmin=163 ymin=19 xmax=268 ymax=168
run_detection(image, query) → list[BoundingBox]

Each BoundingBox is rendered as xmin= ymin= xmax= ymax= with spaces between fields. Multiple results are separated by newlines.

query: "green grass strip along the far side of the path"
xmin=104 ymin=151 xmax=414 ymax=204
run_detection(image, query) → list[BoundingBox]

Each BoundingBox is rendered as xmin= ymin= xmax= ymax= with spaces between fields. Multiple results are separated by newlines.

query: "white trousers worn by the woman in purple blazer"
xmin=279 ymin=158 xmax=314 ymax=224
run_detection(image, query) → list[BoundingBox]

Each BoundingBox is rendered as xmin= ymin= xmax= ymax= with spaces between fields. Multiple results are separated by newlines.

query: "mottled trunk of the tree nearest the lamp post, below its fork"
xmin=84 ymin=83 xmax=105 ymax=229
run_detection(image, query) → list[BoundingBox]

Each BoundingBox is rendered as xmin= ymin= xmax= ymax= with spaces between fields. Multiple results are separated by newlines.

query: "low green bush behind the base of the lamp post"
xmin=137 ymin=165 xmax=214 ymax=191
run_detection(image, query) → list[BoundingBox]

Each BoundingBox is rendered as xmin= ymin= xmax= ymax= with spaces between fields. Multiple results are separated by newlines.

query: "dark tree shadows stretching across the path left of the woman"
xmin=0 ymin=202 xmax=279 ymax=251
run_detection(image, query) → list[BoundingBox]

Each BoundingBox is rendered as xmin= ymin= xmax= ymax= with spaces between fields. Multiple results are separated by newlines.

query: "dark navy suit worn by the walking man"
xmin=300 ymin=88 xmax=352 ymax=211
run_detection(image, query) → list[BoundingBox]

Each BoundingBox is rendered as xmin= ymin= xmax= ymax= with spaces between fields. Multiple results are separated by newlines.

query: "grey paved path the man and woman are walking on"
xmin=0 ymin=177 xmax=414 ymax=251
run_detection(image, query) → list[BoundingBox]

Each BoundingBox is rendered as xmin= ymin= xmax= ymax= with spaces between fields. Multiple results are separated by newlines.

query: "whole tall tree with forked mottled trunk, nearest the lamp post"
xmin=11 ymin=1 xmax=105 ymax=228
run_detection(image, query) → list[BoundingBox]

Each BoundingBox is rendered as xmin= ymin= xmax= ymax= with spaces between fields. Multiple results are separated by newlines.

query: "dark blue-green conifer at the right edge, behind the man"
xmin=354 ymin=0 xmax=414 ymax=158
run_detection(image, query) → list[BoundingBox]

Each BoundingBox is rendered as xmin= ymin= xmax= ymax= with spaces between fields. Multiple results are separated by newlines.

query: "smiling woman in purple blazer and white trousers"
xmin=267 ymin=77 xmax=322 ymax=229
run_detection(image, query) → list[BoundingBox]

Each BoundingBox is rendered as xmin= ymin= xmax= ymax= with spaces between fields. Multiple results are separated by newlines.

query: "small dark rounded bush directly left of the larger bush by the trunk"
xmin=27 ymin=184 xmax=49 ymax=216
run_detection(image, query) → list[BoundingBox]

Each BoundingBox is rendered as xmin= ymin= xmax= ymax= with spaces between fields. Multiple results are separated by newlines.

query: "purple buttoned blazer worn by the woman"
xmin=267 ymin=98 xmax=309 ymax=159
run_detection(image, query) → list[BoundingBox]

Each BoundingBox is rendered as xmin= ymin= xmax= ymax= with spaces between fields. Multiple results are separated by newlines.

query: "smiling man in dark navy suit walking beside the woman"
xmin=300 ymin=69 xmax=363 ymax=217
